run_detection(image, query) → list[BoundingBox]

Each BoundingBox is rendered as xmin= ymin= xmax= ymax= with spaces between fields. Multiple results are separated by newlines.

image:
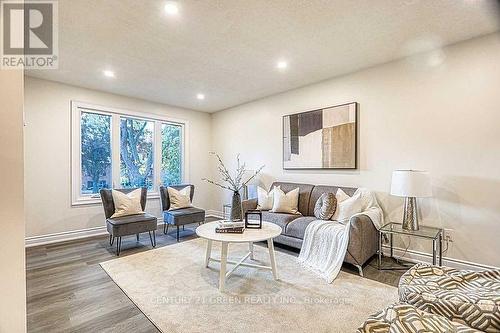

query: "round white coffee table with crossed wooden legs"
xmin=196 ymin=221 xmax=281 ymax=291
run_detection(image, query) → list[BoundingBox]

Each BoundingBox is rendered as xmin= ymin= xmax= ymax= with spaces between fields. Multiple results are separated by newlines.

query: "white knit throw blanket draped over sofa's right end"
xmin=298 ymin=188 xmax=384 ymax=283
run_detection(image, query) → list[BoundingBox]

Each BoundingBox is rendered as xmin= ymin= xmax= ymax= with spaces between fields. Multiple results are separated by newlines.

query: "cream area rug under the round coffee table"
xmin=101 ymin=239 xmax=397 ymax=333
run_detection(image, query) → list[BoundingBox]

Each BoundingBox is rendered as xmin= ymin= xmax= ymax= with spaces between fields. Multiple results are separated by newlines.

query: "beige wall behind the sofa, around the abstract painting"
xmin=212 ymin=33 xmax=500 ymax=266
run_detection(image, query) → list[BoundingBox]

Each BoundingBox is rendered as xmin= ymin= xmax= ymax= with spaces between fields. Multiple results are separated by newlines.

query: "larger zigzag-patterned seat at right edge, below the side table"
xmin=399 ymin=264 xmax=500 ymax=332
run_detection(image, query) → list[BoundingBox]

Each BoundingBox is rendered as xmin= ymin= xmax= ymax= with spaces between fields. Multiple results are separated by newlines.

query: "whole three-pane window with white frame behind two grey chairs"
xmin=72 ymin=101 xmax=187 ymax=205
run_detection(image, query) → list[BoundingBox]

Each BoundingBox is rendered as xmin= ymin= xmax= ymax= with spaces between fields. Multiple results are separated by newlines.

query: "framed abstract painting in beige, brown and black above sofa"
xmin=283 ymin=103 xmax=358 ymax=169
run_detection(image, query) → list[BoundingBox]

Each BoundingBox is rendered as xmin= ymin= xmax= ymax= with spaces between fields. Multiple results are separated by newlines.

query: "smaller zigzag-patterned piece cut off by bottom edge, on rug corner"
xmin=356 ymin=304 xmax=481 ymax=333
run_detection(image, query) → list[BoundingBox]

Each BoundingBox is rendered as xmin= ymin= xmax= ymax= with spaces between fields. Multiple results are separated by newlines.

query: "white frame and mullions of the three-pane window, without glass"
xmin=71 ymin=100 xmax=189 ymax=206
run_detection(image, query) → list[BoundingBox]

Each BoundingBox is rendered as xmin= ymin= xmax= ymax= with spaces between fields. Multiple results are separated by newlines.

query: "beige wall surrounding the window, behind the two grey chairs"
xmin=25 ymin=77 xmax=211 ymax=237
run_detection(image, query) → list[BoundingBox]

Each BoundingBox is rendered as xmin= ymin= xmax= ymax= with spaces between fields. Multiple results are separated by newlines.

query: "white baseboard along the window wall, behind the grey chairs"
xmin=25 ymin=210 xmax=222 ymax=247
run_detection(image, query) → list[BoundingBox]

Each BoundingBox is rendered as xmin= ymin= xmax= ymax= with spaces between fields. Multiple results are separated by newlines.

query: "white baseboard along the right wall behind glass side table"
xmin=382 ymin=246 xmax=499 ymax=271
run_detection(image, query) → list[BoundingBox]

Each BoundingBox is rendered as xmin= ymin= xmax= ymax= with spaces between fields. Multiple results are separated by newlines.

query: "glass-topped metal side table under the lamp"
xmin=377 ymin=222 xmax=443 ymax=270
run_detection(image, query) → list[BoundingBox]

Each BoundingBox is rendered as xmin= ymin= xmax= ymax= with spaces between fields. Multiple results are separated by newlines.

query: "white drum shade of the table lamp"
xmin=391 ymin=170 xmax=432 ymax=198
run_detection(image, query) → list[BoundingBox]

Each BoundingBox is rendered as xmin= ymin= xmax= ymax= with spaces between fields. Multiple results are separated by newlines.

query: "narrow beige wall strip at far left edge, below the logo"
xmin=0 ymin=70 xmax=26 ymax=333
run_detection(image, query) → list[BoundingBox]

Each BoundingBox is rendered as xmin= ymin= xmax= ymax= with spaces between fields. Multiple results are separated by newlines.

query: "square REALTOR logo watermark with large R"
xmin=0 ymin=0 xmax=59 ymax=69
